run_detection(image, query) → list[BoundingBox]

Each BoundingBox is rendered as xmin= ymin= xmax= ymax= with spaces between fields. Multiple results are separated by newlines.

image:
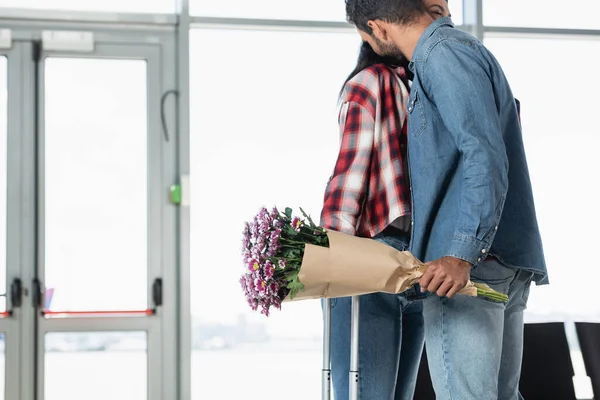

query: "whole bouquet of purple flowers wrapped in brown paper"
xmin=240 ymin=207 xmax=508 ymax=316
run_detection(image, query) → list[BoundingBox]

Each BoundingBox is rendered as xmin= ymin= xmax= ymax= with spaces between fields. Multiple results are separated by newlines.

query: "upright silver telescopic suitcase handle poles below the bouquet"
xmin=321 ymin=296 xmax=360 ymax=400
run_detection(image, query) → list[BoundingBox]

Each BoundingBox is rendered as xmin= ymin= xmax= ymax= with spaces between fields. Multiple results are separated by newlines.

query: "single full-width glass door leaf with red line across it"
xmin=32 ymin=37 xmax=175 ymax=400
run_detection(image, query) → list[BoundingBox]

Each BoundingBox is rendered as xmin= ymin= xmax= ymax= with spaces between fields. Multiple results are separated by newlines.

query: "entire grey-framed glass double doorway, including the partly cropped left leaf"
xmin=0 ymin=21 xmax=179 ymax=400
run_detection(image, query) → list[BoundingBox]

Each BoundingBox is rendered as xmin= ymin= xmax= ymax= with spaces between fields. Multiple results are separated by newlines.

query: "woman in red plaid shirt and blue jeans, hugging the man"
xmin=321 ymin=0 xmax=449 ymax=400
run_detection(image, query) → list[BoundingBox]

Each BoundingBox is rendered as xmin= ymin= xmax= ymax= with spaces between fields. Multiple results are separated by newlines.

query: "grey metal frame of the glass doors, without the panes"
xmin=0 ymin=18 xmax=179 ymax=400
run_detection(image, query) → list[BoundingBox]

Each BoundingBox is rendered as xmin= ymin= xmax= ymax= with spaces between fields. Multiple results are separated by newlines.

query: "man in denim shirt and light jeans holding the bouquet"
xmin=346 ymin=0 xmax=547 ymax=400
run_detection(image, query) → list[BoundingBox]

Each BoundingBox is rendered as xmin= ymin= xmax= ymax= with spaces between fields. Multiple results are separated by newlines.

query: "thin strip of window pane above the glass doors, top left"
xmin=0 ymin=0 xmax=176 ymax=14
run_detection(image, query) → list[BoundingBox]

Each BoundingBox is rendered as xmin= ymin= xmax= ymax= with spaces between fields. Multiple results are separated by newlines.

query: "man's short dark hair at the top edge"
xmin=345 ymin=0 xmax=427 ymax=34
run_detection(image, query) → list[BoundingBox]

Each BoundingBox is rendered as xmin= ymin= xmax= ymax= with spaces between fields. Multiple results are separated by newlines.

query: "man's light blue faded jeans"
xmin=423 ymin=260 xmax=533 ymax=400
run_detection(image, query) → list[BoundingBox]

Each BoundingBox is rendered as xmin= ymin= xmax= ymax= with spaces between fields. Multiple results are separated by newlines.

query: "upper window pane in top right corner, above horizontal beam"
xmin=483 ymin=0 xmax=600 ymax=29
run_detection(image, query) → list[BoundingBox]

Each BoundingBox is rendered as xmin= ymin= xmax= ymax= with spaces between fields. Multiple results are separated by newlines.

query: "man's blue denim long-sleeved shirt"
xmin=407 ymin=18 xmax=547 ymax=284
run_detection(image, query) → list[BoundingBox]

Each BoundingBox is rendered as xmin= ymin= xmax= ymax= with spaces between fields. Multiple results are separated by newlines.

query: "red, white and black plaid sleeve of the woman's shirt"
xmin=321 ymin=102 xmax=375 ymax=235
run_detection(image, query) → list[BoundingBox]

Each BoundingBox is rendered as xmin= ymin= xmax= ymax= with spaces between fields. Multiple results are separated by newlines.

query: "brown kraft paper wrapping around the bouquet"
xmin=285 ymin=231 xmax=477 ymax=301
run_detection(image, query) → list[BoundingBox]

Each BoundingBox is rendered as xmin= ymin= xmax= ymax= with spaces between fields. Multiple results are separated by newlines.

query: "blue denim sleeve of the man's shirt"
xmin=423 ymin=40 xmax=508 ymax=265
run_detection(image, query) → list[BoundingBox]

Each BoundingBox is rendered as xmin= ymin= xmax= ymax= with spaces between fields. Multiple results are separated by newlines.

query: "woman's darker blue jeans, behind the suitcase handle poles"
xmin=322 ymin=231 xmax=424 ymax=400
